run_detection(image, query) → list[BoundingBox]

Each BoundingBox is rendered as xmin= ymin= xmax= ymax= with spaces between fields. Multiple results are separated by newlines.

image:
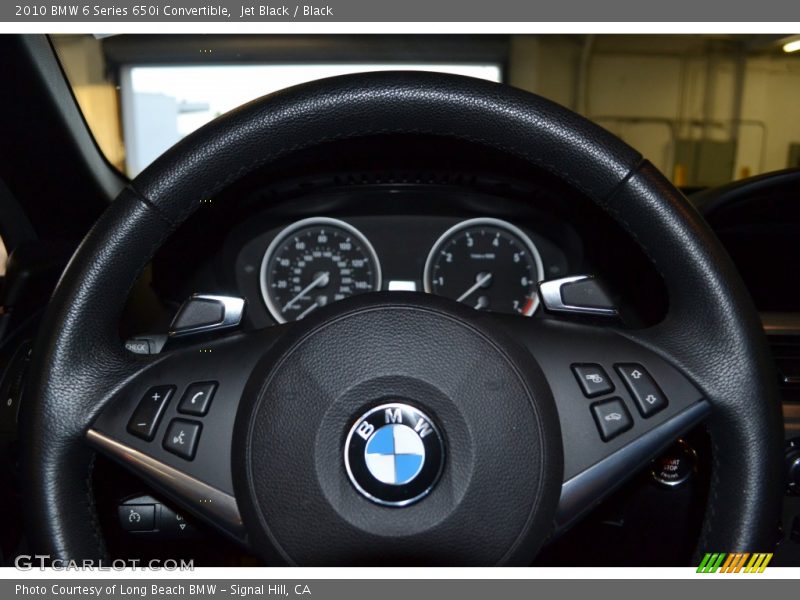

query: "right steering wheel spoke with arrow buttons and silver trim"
xmin=501 ymin=317 xmax=711 ymax=534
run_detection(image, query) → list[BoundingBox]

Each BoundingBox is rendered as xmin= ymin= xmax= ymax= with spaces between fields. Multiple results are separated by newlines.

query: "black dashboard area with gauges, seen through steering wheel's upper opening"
xmin=141 ymin=140 xmax=667 ymax=335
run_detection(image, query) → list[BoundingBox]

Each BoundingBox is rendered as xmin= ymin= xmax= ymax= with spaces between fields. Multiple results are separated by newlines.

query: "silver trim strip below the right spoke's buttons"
xmin=556 ymin=399 xmax=711 ymax=532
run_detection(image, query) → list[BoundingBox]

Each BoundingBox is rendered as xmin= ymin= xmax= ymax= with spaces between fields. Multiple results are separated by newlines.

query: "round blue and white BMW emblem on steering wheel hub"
xmin=344 ymin=403 xmax=444 ymax=506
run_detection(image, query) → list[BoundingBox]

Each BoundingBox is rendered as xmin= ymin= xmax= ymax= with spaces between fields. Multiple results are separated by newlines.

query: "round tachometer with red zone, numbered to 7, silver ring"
xmin=424 ymin=218 xmax=544 ymax=315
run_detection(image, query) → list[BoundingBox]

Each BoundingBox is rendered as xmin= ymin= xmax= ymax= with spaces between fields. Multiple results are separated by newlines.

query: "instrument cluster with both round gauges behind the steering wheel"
xmin=244 ymin=216 xmax=566 ymax=323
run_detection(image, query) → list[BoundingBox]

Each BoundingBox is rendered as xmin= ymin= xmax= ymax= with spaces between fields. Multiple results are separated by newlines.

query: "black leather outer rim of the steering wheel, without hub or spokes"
xmin=21 ymin=73 xmax=782 ymax=558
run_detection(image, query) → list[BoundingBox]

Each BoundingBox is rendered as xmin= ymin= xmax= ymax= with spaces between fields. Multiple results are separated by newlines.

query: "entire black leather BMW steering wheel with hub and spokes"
xmin=21 ymin=73 xmax=782 ymax=565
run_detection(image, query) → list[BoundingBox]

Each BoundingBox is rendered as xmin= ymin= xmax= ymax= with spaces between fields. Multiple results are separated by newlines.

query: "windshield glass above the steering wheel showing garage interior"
xmin=52 ymin=35 xmax=800 ymax=189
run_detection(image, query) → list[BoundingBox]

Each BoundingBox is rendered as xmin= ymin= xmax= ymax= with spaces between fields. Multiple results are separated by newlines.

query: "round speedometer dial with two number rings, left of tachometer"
xmin=261 ymin=217 xmax=381 ymax=323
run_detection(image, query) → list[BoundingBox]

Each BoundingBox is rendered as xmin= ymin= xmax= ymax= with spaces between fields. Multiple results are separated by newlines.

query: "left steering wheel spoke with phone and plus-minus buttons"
xmin=86 ymin=326 xmax=290 ymax=542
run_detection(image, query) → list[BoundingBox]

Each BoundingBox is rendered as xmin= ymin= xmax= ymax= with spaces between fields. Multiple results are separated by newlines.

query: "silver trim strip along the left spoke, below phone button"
xmin=86 ymin=429 xmax=246 ymax=543
